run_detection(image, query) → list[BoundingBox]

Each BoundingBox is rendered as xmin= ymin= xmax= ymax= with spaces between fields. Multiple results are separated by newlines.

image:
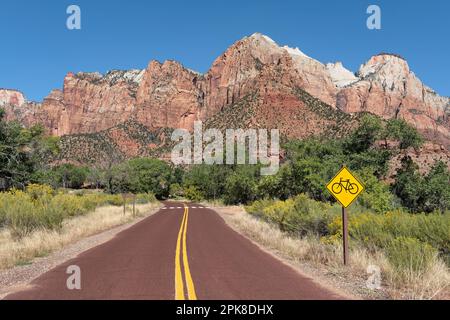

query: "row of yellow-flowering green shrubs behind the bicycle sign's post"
xmin=245 ymin=195 xmax=450 ymax=261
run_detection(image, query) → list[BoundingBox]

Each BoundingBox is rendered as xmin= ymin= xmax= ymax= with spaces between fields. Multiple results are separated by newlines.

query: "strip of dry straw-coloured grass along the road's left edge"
xmin=0 ymin=203 xmax=160 ymax=270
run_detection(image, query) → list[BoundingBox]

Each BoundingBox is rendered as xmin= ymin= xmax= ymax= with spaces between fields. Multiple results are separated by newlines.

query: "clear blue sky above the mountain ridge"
xmin=0 ymin=0 xmax=450 ymax=101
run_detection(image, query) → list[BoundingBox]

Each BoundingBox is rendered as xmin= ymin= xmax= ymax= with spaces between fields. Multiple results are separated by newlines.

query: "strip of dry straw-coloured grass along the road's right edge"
xmin=220 ymin=207 xmax=450 ymax=299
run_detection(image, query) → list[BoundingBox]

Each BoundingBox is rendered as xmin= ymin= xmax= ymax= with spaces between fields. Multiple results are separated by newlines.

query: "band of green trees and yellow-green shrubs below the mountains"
xmin=0 ymin=112 xmax=450 ymax=298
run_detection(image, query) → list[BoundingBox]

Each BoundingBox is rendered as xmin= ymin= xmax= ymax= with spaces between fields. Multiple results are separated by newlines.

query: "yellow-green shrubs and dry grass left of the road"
xmin=0 ymin=184 xmax=158 ymax=269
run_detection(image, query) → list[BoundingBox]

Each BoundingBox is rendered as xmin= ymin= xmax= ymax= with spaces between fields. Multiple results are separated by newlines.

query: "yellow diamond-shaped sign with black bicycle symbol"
xmin=327 ymin=166 xmax=364 ymax=208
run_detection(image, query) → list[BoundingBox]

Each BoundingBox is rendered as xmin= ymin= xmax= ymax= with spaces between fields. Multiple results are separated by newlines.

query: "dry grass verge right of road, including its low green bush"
xmin=223 ymin=207 xmax=450 ymax=299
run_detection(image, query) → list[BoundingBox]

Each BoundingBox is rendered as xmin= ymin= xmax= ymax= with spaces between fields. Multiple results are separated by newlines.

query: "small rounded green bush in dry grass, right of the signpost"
xmin=386 ymin=237 xmax=436 ymax=272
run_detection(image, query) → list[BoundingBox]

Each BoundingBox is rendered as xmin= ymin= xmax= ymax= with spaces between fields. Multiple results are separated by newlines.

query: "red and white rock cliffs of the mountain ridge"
xmin=0 ymin=33 xmax=450 ymax=164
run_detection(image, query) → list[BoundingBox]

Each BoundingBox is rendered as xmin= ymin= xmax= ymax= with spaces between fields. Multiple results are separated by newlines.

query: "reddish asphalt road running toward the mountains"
xmin=6 ymin=202 xmax=342 ymax=300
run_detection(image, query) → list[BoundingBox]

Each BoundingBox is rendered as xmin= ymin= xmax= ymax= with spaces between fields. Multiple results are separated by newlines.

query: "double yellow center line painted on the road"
xmin=175 ymin=205 xmax=197 ymax=300
